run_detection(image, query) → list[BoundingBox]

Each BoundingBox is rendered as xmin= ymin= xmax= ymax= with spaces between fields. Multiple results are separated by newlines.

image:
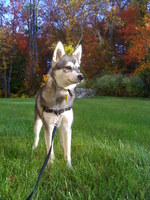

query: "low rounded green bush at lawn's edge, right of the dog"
xmin=92 ymin=74 xmax=145 ymax=97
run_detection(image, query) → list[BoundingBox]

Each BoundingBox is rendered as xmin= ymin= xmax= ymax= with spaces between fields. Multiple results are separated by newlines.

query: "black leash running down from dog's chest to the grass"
xmin=27 ymin=124 xmax=57 ymax=200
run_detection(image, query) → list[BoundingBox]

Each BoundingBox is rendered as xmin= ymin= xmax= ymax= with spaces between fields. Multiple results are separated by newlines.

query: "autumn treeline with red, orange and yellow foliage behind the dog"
xmin=0 ymin=0 xmax=150 ymax=97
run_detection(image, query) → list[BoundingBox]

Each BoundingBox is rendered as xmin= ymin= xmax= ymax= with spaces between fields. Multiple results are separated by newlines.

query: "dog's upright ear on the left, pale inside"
xmin=52 ymin=41 xmax=65 ymax=67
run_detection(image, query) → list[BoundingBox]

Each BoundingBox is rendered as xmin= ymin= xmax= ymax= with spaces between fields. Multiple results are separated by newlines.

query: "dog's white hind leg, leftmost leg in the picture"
xmin=32 ymin=116 xmax=43 ymax=149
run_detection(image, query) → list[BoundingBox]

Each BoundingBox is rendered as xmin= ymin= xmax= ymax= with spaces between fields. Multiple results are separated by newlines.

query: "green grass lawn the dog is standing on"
xmin=0 ymin=97 xmax=150 ymax=200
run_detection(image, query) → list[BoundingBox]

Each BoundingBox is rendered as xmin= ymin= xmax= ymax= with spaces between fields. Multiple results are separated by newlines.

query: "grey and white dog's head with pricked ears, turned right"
xmin=51 ymin=42 xmax=83 ymax=88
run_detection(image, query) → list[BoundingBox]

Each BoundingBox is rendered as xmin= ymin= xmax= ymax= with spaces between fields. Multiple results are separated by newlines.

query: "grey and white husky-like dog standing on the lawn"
xmin=33 ymin=42 xmax=83 ymax=167
